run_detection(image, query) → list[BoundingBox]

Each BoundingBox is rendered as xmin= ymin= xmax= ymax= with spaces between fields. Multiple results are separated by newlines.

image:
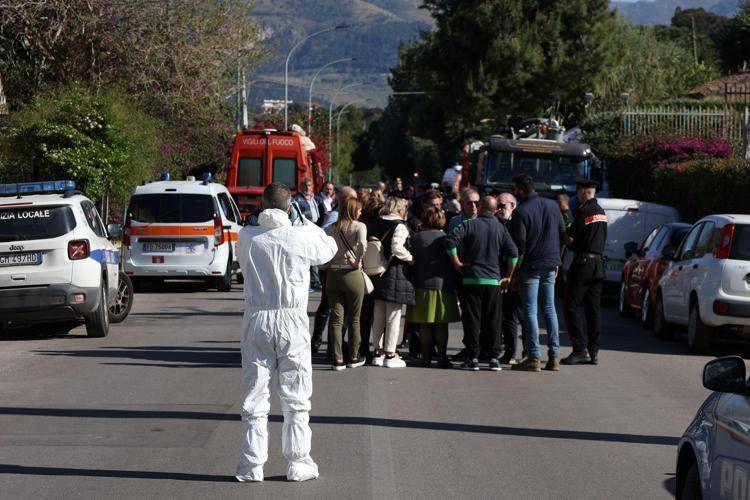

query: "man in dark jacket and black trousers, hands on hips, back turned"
xmin=446 ymin=196 xmax=518 ymax=371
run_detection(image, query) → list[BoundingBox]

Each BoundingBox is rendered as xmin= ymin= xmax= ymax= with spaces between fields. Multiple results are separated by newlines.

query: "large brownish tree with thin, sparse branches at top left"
xmin=0 ymin=0 xmax=262 ymax=177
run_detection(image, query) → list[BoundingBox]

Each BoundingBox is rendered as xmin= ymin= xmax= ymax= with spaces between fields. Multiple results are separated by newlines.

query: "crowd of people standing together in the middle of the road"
xmin=294 ymin=174 xmax=606 ymax=371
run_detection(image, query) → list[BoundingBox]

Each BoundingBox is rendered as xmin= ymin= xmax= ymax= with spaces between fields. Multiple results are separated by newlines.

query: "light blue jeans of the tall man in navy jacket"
xmin=518 ymin=269 xmax=560 ymax=359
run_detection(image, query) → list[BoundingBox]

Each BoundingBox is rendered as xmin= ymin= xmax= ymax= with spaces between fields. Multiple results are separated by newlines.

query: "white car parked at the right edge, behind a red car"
xmin=654 ymin=215 xmax=750 ymax=353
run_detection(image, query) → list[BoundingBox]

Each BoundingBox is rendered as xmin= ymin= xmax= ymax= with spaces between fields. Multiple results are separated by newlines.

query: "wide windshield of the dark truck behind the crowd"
xmin=485 ymin=152 xmax=586 ymax=185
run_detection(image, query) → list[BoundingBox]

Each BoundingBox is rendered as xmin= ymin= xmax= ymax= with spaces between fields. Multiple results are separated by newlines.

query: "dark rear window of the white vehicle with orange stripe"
xmin=128 ymin=193 xmax=215 ymax=223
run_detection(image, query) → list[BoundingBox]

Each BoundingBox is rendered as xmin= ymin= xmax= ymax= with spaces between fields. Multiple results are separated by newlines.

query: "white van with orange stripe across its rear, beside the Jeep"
xmin=122 ymin=177 xmax=241 ymax=291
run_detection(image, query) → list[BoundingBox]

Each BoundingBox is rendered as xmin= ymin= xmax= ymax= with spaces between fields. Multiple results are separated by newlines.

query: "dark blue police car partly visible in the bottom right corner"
xmin=676 ymin=356 xmax=750 ymax=500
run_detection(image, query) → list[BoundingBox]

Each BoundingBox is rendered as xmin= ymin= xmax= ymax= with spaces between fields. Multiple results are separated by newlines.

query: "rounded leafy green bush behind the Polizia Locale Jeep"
xmin=0 ymin=87 xmax=159 ymax=201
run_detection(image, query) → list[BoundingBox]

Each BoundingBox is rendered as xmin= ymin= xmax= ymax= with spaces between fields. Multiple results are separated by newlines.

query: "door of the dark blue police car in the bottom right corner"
xmin=711 ymin=394 xmax=750 ymax=498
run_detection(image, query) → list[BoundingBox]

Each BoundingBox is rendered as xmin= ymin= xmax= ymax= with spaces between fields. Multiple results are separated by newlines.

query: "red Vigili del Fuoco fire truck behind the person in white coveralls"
xmin=226 ymin=129 xmax=326 ymax=217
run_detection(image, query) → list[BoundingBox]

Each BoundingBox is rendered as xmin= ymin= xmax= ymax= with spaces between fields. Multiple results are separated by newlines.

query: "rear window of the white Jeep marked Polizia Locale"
xmin=0 ymin=205 xmax=76 ymax=241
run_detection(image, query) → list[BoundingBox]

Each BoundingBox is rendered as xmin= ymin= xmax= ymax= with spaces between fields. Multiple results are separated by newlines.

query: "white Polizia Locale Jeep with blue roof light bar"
xmin=0 ymin=181 xmax=120 ymax=337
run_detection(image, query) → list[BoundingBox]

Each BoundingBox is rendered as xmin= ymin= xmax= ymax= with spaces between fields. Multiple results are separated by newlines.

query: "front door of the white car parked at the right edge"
xmin=662 ymin=222 xmax=703 ymax=324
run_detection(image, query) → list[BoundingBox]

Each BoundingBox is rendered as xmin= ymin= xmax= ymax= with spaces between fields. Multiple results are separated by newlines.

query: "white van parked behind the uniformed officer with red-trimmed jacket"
xmin=597 ymin=198 xmax=680 ymax=287
